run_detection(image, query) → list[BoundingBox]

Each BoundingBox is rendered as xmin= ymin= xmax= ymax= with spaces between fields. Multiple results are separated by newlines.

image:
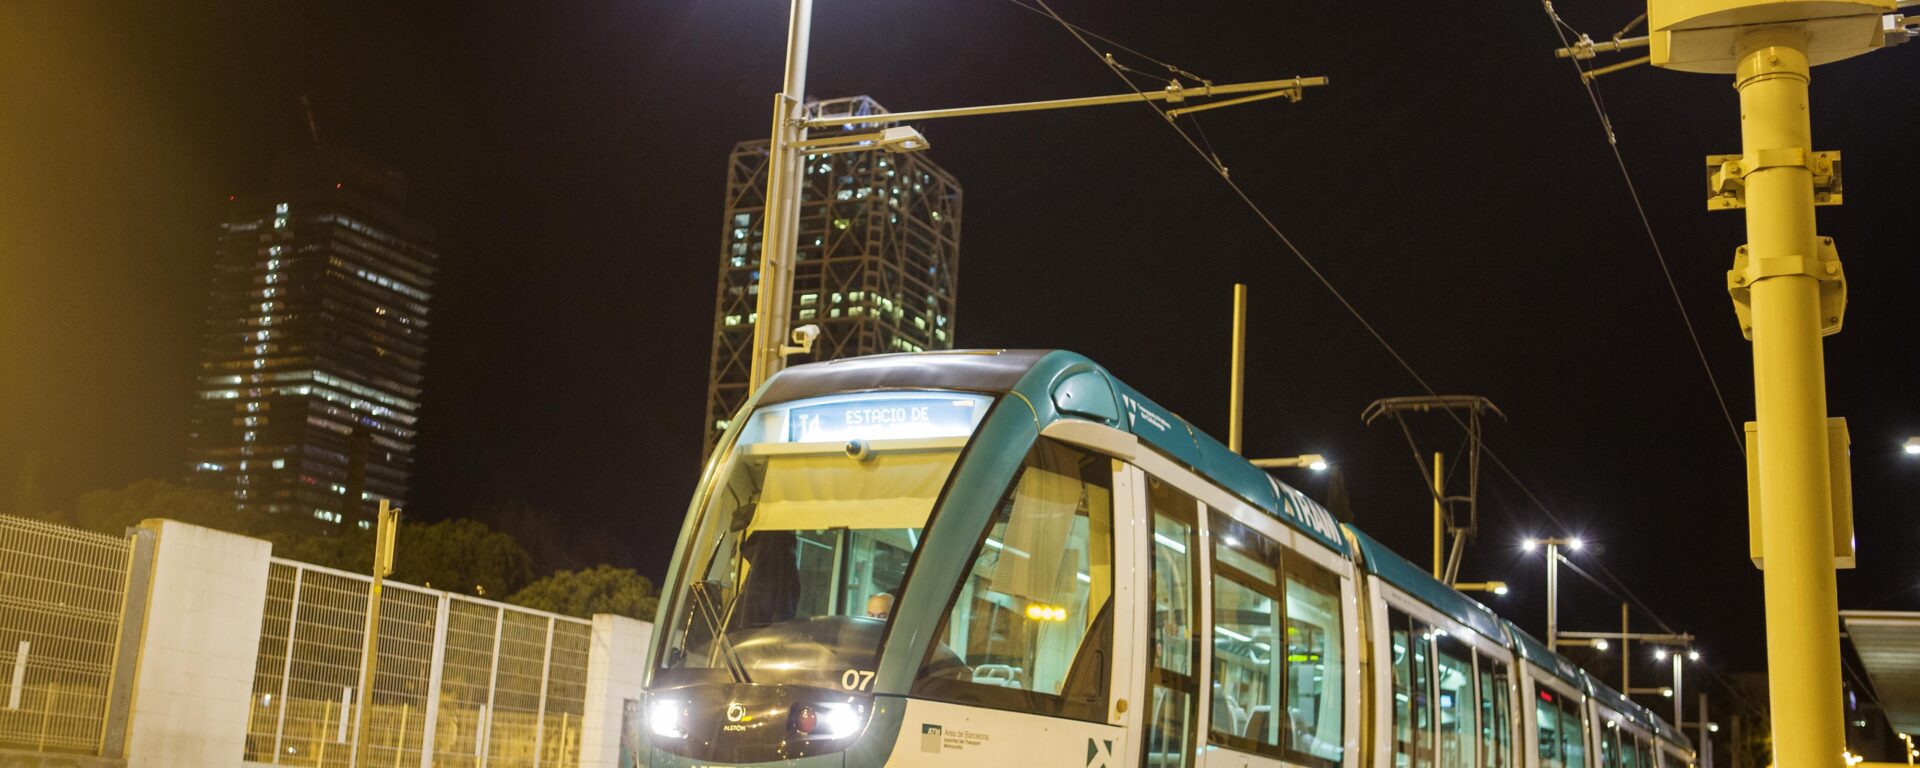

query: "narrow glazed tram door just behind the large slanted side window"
xmin=1135 ymin=472 xmax=1202 ymax=768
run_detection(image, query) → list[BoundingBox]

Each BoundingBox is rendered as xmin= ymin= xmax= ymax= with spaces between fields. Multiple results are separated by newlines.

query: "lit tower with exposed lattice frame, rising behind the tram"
xmin=703 ymin=96 xmax=960 ymax=453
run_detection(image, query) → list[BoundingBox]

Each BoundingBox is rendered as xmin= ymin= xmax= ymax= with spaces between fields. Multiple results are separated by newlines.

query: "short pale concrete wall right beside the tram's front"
xmin=580 ymin=612 xmax=653 ymax=768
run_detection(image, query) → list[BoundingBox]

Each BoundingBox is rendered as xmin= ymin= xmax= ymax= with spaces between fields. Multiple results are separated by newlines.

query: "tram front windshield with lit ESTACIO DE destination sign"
xmin=657 ymin=392 xmax=993 ymax=689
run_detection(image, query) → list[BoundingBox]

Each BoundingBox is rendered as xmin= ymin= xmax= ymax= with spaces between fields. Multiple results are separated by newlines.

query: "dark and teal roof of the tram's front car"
xmin=758 ymin=349 xmax=1348 ymax=555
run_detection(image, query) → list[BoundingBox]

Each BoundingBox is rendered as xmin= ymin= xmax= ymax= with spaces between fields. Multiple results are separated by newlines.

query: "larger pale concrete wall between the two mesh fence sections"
xmin=127 ymin=520 xmax=273 ymax=768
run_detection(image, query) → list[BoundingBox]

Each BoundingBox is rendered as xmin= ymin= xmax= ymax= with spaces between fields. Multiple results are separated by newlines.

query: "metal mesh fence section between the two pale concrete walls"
xmin=246 ymin=559 xmax=591 ymax=768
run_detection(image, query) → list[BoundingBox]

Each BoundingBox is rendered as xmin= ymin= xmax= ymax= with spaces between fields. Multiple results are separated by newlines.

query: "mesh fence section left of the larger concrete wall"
xmin=0 ymin=516 xmax=129 ymax=755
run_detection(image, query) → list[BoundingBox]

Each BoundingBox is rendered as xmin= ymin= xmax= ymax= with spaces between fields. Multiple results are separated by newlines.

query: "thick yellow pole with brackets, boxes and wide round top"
xmin=1647 ymin=0 xmax=1905 ymax=768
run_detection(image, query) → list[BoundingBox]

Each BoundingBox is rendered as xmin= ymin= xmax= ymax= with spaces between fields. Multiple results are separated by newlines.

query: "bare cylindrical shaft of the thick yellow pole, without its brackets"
xmin=1736 ymin=27 xmax=1845 ymax=766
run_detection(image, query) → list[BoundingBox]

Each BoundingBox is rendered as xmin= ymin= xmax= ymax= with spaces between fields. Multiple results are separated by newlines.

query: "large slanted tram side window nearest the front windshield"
xmin=914 ymin=440 xmax=1114 ymax=722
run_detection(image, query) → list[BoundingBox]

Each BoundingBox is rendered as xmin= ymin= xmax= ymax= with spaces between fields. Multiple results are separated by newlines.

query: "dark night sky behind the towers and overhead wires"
xmin=0 ymin=0 xmax=1920 ymax=683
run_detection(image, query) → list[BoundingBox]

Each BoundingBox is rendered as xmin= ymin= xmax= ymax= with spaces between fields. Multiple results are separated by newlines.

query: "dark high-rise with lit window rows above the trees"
xmin=190 ymin=146 xmax=438 ymax=530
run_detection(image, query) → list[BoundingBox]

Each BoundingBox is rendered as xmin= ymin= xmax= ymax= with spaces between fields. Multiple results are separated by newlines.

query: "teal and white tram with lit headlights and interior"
xmin=637 ymin=349 xmax=1692 ymax=768
